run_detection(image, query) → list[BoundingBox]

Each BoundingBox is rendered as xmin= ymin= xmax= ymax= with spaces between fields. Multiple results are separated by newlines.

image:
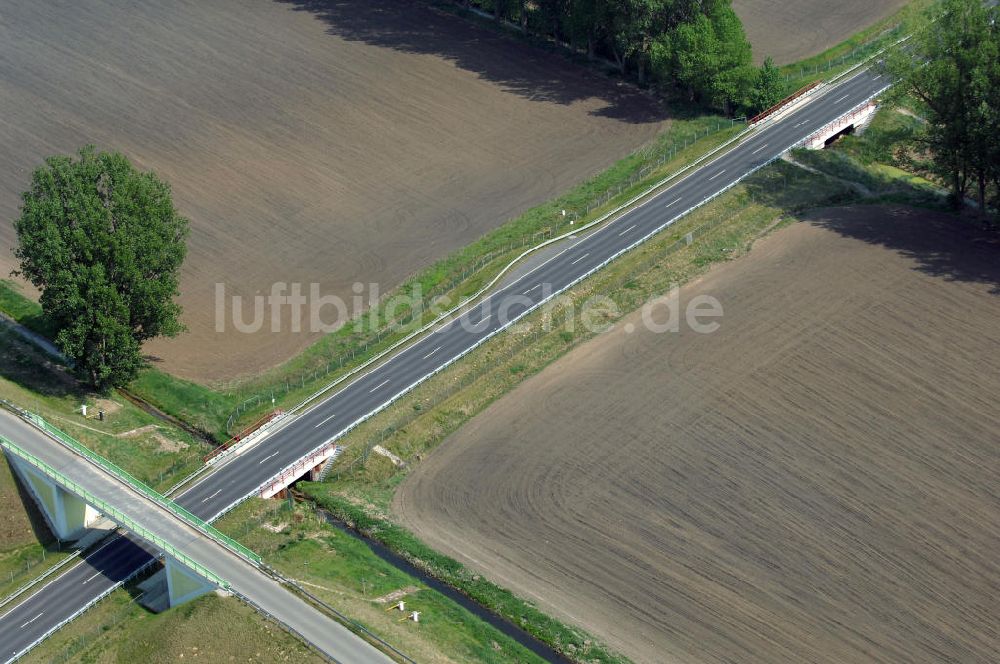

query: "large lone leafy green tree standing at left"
xmin=14 ymin=146 xmax=188 ymax=389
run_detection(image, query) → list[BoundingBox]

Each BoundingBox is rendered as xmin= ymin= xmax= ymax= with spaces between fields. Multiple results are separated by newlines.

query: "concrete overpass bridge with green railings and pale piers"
xmin=0 ymin=409 xmax=393 ymax=663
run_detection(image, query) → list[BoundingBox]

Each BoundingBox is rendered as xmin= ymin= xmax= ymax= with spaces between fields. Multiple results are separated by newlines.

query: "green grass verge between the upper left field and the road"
xmin=130 ymin=116 xmax=742 ymax=441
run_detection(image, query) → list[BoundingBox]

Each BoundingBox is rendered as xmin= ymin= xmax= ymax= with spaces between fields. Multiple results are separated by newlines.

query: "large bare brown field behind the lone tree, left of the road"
xmin=0 ymin=0 xmax=666 ymax=381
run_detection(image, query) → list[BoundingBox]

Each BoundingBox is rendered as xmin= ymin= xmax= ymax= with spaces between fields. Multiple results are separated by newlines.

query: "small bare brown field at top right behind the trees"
xmin=733 ymin=0 xmax=908 ymax=65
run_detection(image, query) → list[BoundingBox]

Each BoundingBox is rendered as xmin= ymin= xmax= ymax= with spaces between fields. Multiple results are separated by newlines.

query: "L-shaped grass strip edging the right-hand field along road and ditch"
xmin=292 ymin=101 xmax=942 ymax=661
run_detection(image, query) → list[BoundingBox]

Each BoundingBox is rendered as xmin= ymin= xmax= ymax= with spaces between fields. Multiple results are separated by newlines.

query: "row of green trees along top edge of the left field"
xmin=466 ymin=0 xmax=785 ymax=113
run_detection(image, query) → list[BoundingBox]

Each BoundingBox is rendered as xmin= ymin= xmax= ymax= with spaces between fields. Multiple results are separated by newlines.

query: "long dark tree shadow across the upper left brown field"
xmin=275 ymin=0 xmax=667 ymax=124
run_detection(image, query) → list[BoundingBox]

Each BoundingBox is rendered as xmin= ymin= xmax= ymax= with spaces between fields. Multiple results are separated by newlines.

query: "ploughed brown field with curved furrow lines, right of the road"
xmin=393 ymin=207 xmax=1000 ymax=663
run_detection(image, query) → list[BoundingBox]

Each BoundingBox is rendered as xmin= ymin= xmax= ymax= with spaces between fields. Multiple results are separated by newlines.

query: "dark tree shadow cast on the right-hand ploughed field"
xmin=807 ymin=205 xmax=1000 ymax=295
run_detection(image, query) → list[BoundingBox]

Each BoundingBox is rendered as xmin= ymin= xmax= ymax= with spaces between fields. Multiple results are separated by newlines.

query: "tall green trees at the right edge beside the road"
xmin=885 ymin=0 xmax=1000 ymax=211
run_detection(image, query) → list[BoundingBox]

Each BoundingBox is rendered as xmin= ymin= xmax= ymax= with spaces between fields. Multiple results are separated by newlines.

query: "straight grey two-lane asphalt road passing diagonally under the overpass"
xmin=0 ymin=63 xmax=889 ymax=653
